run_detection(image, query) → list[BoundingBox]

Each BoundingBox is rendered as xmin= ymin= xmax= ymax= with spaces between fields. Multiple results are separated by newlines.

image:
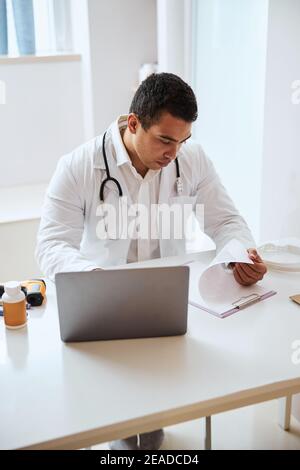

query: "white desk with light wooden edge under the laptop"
xmin=0 ymin=255 xmax=300 ymax=449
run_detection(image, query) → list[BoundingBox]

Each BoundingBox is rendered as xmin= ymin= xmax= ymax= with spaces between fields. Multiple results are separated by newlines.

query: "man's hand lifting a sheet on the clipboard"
xmin=232 ymin=248 xmax=267 ymax=286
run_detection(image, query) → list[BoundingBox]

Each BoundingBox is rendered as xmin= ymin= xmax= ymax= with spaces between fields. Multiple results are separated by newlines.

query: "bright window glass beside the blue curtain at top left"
xmin=6 ymin=0 xmax=72 ymax=56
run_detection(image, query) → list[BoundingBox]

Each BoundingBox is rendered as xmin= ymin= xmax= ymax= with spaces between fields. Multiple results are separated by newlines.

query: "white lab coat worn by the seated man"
xmin=36 ymin=118 xmax=255 ymax=280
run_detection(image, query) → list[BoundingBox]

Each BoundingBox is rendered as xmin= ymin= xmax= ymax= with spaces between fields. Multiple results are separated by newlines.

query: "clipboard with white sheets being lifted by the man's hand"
xmin=189 ymin=239 xmax=276 ymax=318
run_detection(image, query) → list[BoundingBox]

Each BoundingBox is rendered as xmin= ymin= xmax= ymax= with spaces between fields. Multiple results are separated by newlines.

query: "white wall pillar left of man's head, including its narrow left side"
xmin=71 ymin=0 xmax=157 ymax=140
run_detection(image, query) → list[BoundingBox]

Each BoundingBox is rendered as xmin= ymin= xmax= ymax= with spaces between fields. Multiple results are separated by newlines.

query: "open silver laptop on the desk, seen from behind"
xmin=55 ymin=266 xmax=189 ymax=342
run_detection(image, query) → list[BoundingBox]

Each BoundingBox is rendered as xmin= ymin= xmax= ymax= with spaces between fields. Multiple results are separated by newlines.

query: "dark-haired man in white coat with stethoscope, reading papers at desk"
xmin=36 ymin=73 xmax=266 ymax=449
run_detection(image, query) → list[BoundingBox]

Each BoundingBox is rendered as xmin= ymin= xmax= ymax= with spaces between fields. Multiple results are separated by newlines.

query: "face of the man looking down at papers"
xmin=132 ymin=112 xmax=192 ymax=170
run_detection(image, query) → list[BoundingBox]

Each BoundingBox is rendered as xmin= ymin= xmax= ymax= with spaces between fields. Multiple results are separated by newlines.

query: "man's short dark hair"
xmin=129 ymin=73 xmax=198 ymax=130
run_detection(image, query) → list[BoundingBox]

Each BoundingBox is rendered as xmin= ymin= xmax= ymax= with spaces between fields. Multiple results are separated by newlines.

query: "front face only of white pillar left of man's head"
xmin=88 ymin=0 xmax=157 ymax=134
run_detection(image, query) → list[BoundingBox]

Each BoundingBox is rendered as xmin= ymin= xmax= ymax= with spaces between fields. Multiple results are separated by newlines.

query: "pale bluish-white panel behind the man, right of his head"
xmin=193 ymin=0 xmax=268 ymax=242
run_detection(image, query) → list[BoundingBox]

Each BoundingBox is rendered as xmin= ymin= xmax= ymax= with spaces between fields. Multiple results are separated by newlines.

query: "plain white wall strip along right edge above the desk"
xmin=260 ymin=0 xmax=300 ymax=240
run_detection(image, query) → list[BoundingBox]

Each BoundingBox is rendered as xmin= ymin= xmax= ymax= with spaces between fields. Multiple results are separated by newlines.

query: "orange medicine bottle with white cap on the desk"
xmin=2 ymin=281 xmax=27 ymax=330
